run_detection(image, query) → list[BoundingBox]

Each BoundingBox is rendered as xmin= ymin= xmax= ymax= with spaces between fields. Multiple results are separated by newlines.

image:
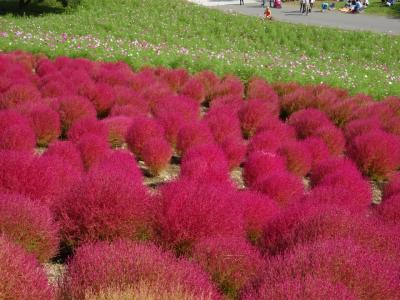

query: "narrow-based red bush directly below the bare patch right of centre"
xmin=234 ymin=190 xmax=280 ymax=245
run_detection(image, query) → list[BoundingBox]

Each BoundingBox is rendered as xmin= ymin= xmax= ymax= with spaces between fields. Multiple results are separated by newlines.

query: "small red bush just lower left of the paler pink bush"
xmin=77 ymin=133 xmax=110 ymax=170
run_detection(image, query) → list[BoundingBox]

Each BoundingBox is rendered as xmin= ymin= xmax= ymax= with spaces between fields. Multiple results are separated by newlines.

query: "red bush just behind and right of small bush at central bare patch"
xmin=176 ymin=122 xmax=214 ymax=154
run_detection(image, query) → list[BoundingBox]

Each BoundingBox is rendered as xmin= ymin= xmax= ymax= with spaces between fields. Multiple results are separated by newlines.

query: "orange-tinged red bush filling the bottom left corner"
xmin=0 ymin=236 xmax=55 ymax=300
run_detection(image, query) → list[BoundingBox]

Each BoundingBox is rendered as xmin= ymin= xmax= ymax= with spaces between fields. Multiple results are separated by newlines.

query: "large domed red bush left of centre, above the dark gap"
xmin=57 ymin=165 xmax=150 ymax=246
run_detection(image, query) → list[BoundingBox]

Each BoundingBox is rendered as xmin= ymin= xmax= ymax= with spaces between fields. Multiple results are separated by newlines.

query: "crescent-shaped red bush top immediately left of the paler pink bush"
xmin=68 ymin=117 xmax=108 ymax=144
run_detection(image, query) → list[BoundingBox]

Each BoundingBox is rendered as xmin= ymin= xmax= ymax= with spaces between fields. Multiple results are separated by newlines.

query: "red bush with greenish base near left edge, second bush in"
xmin=18 ymin=104 xmax=61 ymax=147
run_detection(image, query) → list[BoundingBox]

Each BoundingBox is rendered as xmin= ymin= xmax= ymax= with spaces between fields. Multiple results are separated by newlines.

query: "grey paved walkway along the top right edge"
xmin=190 ymin=0 xmax=400 ymax=35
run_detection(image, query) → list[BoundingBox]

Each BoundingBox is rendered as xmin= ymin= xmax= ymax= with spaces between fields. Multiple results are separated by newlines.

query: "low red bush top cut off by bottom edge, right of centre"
xmin=247 ymin=275 xmax=357 ymax=300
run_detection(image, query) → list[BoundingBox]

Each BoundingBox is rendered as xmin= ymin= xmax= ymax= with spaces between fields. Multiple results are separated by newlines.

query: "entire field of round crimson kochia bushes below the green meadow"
xmin=0 ymin=51 xmax=400 ymax=299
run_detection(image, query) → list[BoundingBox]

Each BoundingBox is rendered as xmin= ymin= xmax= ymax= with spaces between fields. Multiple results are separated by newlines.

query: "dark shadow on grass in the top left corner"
xmin=0 ymin=0 xmax=71 ymax=17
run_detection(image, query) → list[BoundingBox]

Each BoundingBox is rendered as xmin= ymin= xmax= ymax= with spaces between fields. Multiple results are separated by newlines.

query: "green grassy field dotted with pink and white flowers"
xmin=0 ymin=0 xmax=400 ymax=98
